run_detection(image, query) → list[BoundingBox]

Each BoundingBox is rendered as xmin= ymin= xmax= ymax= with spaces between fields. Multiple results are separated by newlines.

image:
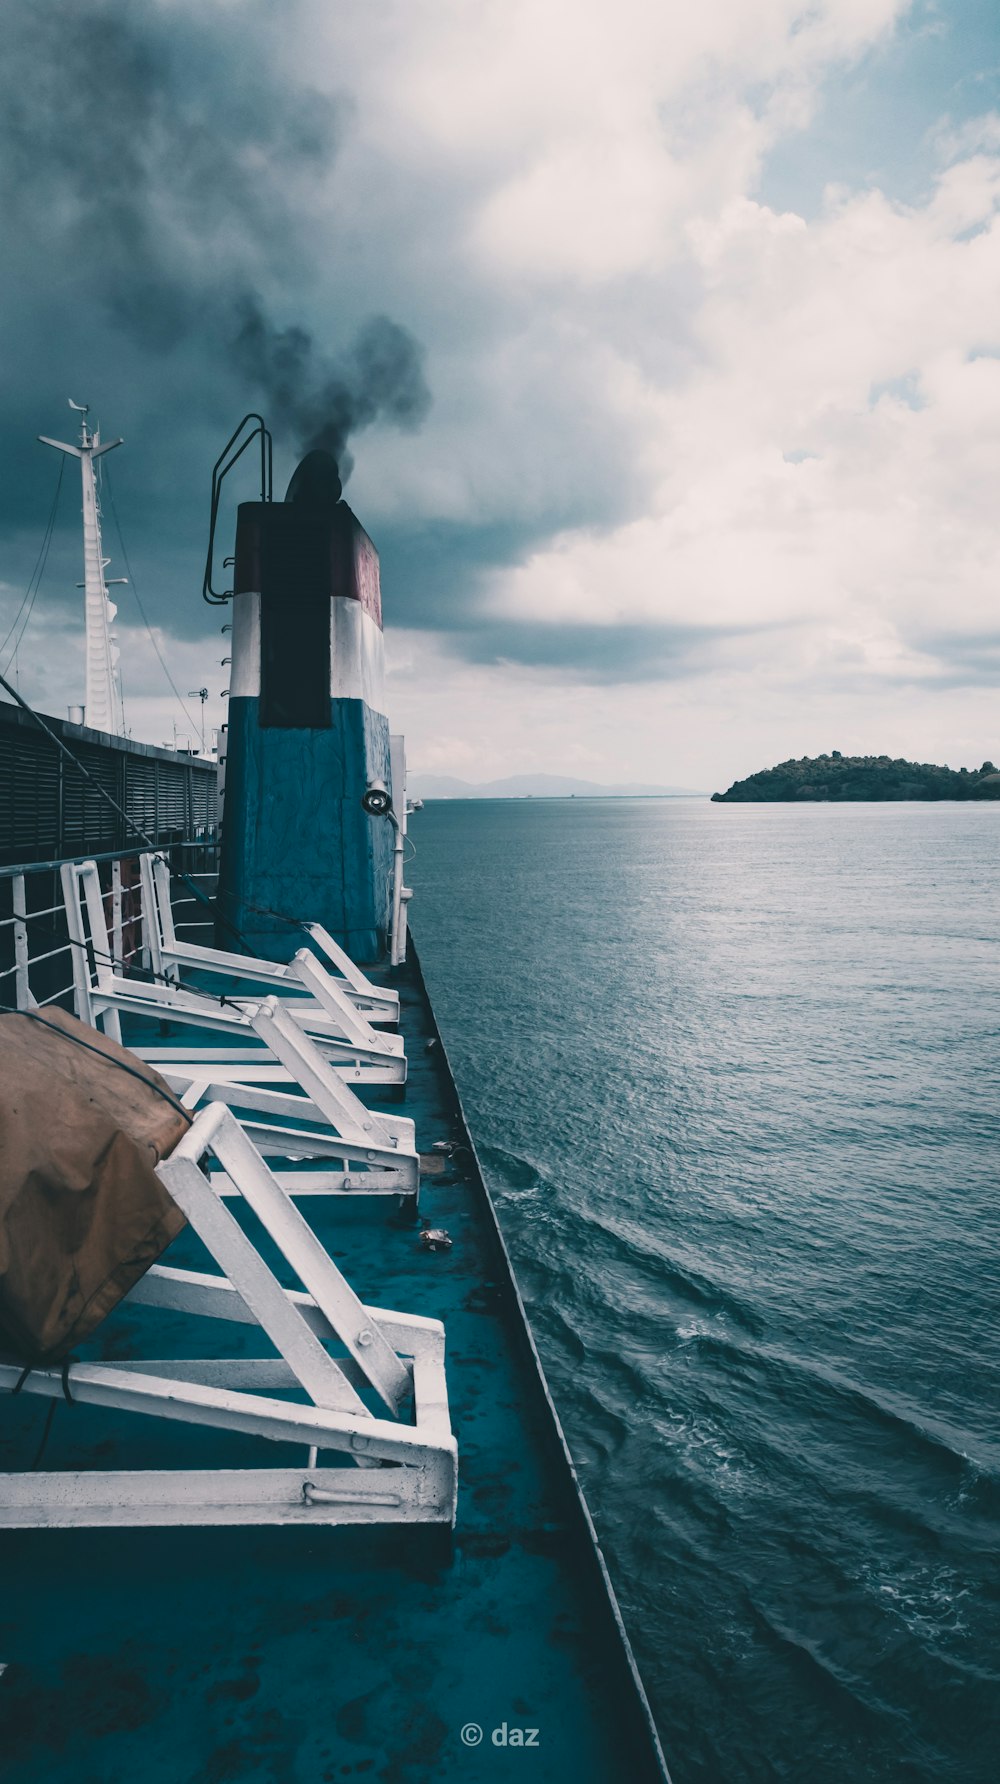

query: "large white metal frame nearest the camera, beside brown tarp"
xmin=0 ymin=1103 xmax=458 ymax=1529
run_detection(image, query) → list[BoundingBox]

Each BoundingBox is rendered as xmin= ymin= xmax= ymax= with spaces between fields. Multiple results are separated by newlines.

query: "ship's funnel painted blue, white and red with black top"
xmin=219 ymin=455 xmax=394 ymax=962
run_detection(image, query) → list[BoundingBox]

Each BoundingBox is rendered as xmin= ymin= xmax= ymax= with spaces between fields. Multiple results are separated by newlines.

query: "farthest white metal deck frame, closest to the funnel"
xmin=139 ymin=855 xmax=399 ymax=1024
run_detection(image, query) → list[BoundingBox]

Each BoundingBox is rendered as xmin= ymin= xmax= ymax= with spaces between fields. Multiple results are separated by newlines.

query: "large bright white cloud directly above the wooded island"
xmin=474 ymin=137 xmax=1000 ymax=717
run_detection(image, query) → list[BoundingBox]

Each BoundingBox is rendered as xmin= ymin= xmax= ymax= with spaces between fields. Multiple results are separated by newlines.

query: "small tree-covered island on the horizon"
xmin=711 ymin=749 xmax=1000 ymax=805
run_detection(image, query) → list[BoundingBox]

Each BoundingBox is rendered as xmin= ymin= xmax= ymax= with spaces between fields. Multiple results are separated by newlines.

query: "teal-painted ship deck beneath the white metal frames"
xmin=0 ymin=958 xmax=665 ymax=1784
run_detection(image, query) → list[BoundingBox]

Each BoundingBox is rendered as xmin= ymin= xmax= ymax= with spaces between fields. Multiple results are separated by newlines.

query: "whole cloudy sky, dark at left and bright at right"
xmin=0 ymin=0 xmax=1000 ymax=789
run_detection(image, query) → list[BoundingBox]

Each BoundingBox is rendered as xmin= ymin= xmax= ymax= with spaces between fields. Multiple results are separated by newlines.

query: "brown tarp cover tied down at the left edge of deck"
xmin=0 ymin=1008 xmax=189 ymax=1365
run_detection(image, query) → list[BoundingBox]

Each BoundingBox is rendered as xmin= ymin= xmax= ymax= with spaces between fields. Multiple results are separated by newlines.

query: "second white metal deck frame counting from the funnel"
xmin=61 ymin=860 xmax=406 ymax=1085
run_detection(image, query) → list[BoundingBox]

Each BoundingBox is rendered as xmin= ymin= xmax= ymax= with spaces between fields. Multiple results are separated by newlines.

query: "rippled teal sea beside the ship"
xmin=408 ymin=799 xmax=1000 ymax=1784
